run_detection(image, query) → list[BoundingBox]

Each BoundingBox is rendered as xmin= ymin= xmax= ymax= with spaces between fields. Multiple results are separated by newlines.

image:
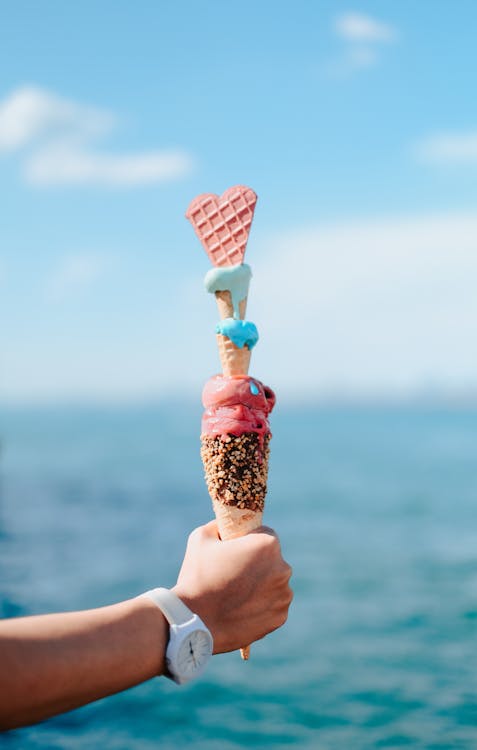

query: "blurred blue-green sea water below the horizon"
xmin=0 ymin=405 xmax=477 ymax=750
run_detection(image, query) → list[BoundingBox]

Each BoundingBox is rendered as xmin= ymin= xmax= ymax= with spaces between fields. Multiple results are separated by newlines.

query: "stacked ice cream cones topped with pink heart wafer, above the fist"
xmin=186 ymin=185 xmax=275 ymax=539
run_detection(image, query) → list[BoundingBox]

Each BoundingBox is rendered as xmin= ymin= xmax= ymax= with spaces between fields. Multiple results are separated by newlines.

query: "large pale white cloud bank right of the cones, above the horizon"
xmin=249 ymin=214 xmax=477 ymax=394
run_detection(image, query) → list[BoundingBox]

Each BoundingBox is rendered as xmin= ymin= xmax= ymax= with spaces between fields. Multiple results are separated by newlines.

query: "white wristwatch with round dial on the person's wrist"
xmin=141 ymin=588 xmax=214 ymax=685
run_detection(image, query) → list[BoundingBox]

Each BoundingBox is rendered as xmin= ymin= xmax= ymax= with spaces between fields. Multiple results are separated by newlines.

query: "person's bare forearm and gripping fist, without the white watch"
xmin=0 ymin=522 xmax=292 ymax=729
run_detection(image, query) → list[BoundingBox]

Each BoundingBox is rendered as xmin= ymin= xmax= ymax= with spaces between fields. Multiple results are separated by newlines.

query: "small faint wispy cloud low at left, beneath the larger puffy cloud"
xmin=46 ymin=253 xmax=108 ymax=302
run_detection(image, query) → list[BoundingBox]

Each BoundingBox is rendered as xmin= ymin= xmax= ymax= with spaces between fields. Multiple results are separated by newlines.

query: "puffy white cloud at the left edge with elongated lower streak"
xmin=0 ymin=87 xmax=193 ymax=187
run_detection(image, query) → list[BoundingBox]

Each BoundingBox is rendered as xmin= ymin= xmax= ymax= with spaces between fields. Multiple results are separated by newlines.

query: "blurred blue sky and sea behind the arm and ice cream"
xmin=0 ymin=0 xmax=477 ymax=750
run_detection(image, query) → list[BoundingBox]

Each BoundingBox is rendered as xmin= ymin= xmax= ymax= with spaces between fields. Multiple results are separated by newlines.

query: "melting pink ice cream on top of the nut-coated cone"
xmin=202 ymin=375 xmax=275 ymax=442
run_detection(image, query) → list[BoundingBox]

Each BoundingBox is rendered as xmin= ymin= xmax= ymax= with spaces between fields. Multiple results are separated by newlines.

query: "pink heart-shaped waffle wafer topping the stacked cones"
xmin=186 ymin=185 xmax=257 ymax=266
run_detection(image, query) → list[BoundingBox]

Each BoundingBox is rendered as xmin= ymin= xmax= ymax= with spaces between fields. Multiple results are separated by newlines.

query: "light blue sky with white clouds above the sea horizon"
xmin=0 ymin=0 xmax=477 ymax=404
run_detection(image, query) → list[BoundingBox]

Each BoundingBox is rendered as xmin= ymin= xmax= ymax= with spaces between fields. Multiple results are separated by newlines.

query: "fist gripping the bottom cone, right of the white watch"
xmin=173 ymin=521 xmax=293 ymax=653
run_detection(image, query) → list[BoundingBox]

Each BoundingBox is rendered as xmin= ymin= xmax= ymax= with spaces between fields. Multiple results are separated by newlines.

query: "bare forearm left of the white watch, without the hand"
xmin=0 ymin=598 xmax=168 ymax=729
